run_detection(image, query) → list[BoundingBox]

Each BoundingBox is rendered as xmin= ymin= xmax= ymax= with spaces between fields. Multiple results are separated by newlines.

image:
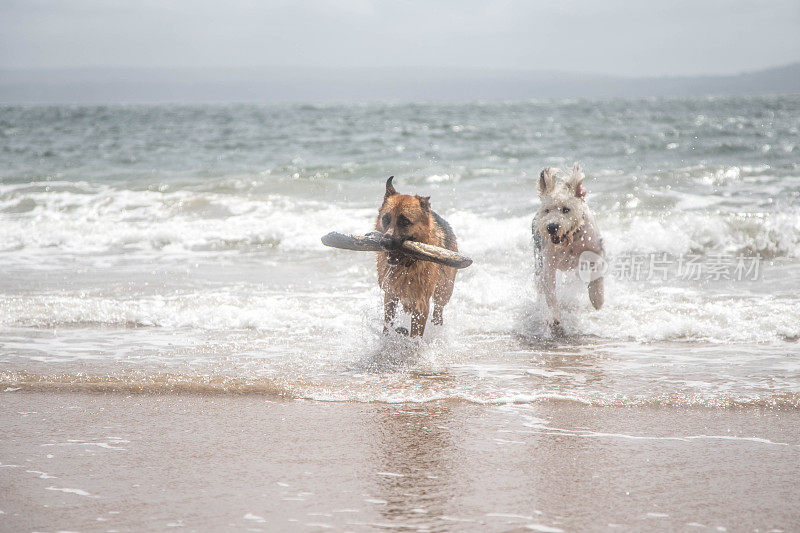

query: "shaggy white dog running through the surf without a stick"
xmin=531 ymin=163 xmax=605 ymax=326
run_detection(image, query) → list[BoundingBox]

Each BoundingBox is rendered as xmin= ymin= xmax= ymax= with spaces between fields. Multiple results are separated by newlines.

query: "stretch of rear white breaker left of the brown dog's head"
xmin=0 ymin=184 xmax=373 ymax=255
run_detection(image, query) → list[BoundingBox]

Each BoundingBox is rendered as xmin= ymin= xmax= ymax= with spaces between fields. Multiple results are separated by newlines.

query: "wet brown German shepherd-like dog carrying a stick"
xmin=375 ymin=176 xmax=458 ymax=337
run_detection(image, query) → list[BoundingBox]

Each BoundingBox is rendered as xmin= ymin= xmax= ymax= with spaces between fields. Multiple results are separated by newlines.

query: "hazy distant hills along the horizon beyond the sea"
xmin=0 ymin=63 xmax=800 ymax=104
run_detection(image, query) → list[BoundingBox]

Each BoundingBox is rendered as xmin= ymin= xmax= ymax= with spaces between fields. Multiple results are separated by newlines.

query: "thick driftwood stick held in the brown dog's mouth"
xmin=322 ymin=231 xmax=472 ymax=268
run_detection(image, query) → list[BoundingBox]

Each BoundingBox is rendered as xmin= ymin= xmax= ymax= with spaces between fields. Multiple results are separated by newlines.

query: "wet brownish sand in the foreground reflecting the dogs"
xmin=0 ymin=390 xmax=800 ymax=532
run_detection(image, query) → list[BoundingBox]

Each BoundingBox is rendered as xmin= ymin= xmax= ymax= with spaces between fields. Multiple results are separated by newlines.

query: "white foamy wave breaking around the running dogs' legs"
xmin=0 ymin=276 xmax=800 ymax=343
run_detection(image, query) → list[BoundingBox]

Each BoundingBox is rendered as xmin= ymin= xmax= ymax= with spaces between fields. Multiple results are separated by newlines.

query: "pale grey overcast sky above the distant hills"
xmin=0 ymin=0 xmax=800 ymax=76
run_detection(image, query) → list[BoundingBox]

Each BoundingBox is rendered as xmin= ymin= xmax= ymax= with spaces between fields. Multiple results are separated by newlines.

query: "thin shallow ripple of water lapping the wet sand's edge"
xmin=0 ymin=370 xmax=800 ymax=409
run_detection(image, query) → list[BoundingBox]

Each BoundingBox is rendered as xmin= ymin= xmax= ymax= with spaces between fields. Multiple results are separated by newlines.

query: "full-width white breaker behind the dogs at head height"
xmin=0 ymin=183 xmax=800 ymax=260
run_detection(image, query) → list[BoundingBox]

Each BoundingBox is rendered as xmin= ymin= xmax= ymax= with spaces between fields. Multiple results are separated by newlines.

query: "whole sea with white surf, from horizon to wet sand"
xmin=0 ymin=96 xmax=800 ymax=408
